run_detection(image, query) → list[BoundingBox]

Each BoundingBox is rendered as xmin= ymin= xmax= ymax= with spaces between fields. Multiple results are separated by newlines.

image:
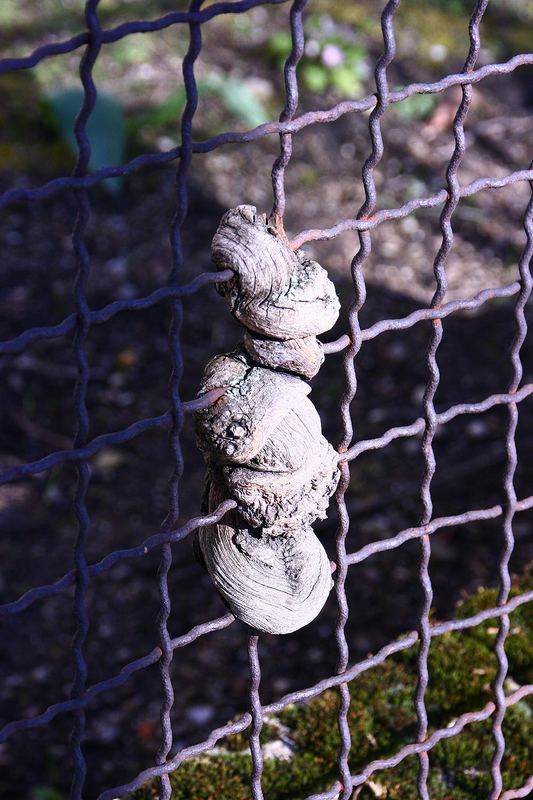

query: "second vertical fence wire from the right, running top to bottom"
xmin=415 ymin=0 xmax=488 ymax=800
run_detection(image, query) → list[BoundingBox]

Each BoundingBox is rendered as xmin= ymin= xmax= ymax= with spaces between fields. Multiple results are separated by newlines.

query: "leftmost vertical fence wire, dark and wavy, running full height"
xmin=70 ymin=0 xmax=102 ymax=800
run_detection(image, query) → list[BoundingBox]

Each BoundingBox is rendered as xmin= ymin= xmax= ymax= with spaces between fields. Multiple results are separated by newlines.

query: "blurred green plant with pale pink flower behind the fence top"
xmin=267 ymin=15 xmax=369 ymax=98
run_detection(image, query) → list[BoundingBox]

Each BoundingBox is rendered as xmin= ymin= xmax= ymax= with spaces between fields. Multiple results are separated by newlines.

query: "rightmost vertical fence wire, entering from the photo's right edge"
xmin=489 ymin=183 xmax=533 ymax=800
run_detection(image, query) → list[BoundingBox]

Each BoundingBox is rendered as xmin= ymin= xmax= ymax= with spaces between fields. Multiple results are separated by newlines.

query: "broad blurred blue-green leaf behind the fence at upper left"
xmin=47 ymin=88 xmax=126 ymax=194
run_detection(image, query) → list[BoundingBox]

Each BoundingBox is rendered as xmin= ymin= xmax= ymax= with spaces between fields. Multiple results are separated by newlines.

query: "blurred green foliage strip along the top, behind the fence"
xmin=0 ymin=0 xmax=533 ymax=183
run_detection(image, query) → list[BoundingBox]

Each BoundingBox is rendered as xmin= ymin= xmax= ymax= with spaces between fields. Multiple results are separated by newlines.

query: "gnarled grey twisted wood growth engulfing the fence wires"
xmin=195 ymin=205 xmax=339 ymax=633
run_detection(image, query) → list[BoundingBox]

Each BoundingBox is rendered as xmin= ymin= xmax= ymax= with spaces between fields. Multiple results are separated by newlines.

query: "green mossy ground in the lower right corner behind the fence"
xmin=132 ymin=570 xmax=533 ymax=800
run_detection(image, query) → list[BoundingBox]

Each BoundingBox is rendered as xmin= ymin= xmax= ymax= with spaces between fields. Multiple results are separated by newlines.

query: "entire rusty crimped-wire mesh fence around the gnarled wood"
xmin=0 ymin=0 xmax=533 ymax=800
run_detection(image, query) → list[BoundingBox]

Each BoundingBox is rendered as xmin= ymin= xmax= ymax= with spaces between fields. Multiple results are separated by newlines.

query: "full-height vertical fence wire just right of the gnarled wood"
xmin=335 ymin=0 xmax=400 ymax=800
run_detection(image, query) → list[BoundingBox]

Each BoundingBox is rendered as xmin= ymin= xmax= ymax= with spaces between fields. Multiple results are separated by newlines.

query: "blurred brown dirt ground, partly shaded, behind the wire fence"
xmin=0 ymin=3 xmax=533 ymax=800
